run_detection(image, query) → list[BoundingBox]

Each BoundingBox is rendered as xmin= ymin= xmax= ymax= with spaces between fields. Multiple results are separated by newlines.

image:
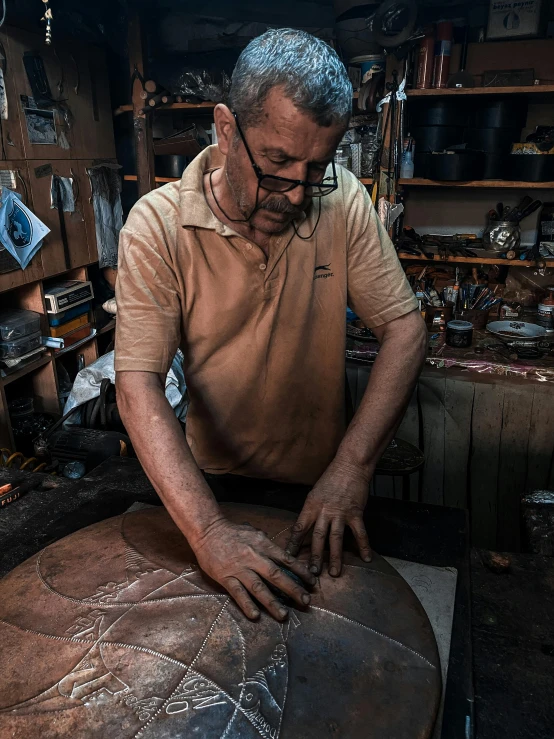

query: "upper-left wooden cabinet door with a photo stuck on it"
xmin=5 ymin=28 xmax=78 ymax=159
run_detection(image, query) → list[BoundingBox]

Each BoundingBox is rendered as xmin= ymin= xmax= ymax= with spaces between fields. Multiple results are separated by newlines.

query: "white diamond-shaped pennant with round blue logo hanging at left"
xmin=0 ymin=187 xmax=50 ymax=269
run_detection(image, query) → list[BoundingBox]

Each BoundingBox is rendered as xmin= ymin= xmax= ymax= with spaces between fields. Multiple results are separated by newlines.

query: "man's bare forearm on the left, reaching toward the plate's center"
xmin=116 ymin=372 xmax=222 ymax=541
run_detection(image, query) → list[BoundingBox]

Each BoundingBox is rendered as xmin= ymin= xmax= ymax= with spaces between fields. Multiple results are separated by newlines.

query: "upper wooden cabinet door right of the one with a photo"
xmin=68 ymin=45 xmax=115 ymax=159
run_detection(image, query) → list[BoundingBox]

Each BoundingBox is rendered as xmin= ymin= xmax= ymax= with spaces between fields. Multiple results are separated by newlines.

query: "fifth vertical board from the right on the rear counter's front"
xmin=419 ymin=376 xmax=446 ymax=505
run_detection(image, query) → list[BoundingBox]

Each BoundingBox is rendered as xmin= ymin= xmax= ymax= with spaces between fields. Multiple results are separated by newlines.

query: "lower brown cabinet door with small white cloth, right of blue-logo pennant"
xmin=29 ymin=159 xmax=91 ymax=277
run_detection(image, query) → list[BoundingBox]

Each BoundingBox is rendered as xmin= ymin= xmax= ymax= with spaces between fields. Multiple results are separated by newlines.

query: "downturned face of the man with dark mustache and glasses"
xmin=220 ymin=88 xmax=345 ymax=234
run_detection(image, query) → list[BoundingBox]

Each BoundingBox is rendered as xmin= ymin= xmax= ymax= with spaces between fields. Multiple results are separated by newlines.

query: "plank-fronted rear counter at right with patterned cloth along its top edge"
xmin=346 ymin=331 xmax=554 ymax=552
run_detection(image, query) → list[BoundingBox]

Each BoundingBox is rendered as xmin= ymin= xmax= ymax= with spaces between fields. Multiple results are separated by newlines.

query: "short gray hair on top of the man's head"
xmin=229 ymin=28 xmax=352 ymax=128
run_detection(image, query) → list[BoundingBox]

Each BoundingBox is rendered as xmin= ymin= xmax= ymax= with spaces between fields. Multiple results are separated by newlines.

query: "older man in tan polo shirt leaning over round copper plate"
xmin=115 ymin=29 xmax=426 ymax=619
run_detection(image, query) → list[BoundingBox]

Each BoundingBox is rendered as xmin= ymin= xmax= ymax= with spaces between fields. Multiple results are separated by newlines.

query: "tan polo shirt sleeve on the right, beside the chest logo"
xmin=346 ymin=178 xmax=417 ymax=328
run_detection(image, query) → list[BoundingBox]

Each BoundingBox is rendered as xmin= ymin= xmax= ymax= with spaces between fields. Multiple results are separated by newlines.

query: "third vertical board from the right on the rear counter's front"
xmin=469 ymin=384 xmax=504 ymax=549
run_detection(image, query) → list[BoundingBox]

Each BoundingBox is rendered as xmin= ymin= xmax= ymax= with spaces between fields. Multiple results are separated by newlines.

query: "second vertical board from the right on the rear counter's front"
xmin=497 ymin=385 xmax=534 ymax=552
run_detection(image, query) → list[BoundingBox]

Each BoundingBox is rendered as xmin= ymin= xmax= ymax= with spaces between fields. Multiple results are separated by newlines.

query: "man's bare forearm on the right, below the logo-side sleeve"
xmin=335 ymin=314 xmax=427 ymax=478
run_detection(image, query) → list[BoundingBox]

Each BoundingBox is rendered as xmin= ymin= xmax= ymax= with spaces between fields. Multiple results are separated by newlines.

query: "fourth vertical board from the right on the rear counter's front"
xmin=444 ymin=376 xmax=475 ymax=508
